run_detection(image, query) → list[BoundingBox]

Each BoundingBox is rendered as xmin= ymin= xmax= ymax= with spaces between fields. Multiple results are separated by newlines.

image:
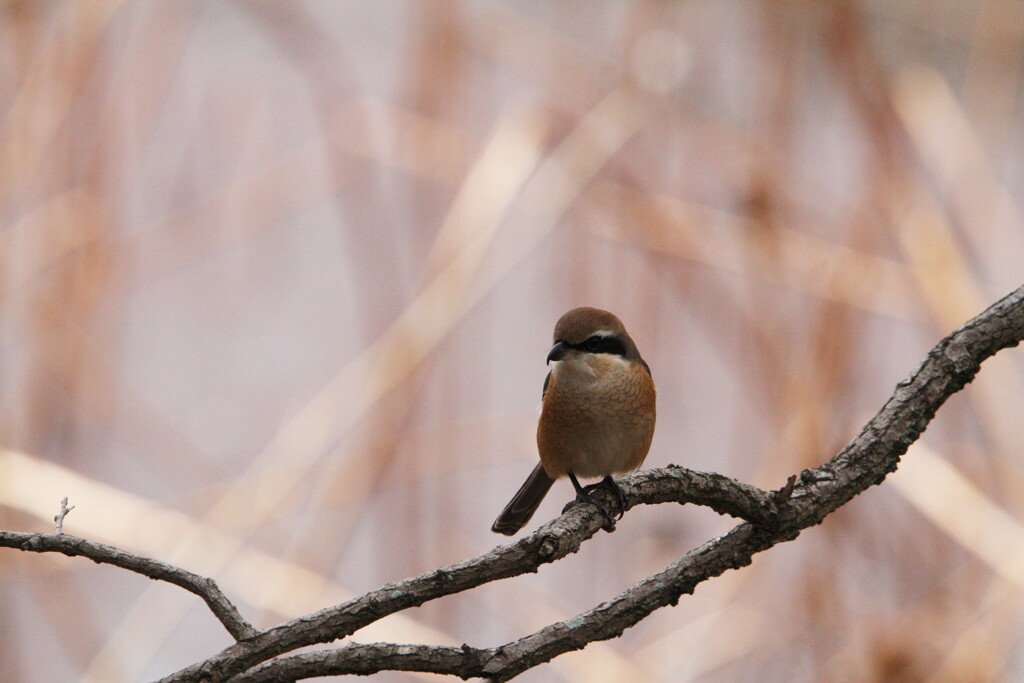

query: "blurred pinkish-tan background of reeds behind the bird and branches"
xmin=0 ymin=0 xmax=1024 ymax=682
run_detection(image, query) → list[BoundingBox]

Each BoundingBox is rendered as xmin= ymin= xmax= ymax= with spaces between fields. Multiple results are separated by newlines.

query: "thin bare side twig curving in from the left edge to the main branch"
xmin=0 ymin=532 xmax=257 ymax=640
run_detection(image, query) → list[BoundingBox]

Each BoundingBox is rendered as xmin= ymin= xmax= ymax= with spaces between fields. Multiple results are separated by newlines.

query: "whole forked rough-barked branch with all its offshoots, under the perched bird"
xmin=0 ymin=287 xmax=1024 ymax=681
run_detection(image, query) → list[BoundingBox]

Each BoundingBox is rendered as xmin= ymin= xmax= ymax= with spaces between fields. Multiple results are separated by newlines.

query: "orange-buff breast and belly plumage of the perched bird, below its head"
xmin=537 ymin=354 xmax=656 ymax=479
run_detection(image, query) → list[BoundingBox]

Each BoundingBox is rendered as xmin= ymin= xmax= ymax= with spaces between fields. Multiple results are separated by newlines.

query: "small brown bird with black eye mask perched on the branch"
xmin=490 ymin=306 xmax=656 ymax=536
